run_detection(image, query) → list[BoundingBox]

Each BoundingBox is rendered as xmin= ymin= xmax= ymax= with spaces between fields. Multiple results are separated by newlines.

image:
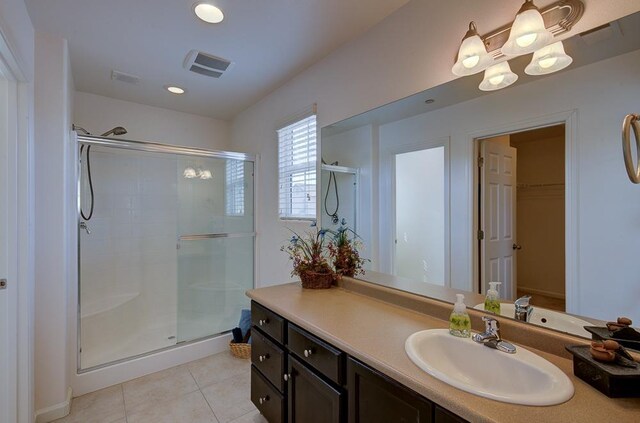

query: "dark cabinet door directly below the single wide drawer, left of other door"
xmin=288 ymin=356 xmax=346 ymax=423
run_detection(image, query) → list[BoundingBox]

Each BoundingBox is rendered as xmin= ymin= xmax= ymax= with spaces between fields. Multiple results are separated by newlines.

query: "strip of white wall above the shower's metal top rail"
xmin=73 ymin=91 xmax=231 ymax=150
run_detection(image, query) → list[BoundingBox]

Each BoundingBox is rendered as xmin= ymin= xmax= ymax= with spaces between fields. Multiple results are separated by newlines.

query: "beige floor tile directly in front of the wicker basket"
xmin=187 ymin=351 xmax=251 ymax=388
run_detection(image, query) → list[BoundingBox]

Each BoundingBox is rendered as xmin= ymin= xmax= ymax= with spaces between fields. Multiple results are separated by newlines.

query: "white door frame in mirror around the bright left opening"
xmin=379 ymin=137 xmax=451 ymax=287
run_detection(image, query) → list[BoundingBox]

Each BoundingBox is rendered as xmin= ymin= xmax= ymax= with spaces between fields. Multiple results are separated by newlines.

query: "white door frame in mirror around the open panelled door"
xmin=468 ymin=110 xmax=580 ymax=313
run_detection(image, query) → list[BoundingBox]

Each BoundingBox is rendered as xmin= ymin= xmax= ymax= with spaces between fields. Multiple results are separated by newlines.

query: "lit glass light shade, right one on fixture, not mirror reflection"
xmin=502 ymin=1 xmax=553 ymax=56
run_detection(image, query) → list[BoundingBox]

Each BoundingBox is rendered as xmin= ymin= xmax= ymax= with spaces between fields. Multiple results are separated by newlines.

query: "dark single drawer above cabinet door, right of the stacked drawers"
xmin=287 ymin=323 xmax=345 ymax=386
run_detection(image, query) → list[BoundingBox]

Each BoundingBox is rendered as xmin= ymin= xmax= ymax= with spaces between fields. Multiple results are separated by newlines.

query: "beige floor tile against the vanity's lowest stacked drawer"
xmin=202 ymin=372 xmax=256 ymax=423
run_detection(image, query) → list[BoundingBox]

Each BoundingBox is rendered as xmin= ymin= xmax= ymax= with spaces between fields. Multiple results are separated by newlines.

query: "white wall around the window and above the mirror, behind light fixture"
xmin=232 ymin=0 xmax=640 ymax=285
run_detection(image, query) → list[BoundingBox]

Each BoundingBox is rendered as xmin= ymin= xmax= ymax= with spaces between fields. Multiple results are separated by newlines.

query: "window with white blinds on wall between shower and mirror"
xmin=278 ymin=114 xmax=316 ymax=220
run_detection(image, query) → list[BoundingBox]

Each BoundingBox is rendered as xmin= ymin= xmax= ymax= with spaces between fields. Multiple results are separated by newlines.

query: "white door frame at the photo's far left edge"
xmin=0 ymin=28 xmax=34 ymax=423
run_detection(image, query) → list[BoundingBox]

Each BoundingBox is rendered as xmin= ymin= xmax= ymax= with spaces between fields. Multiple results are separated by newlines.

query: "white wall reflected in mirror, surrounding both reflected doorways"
xmin=380 ymin=51 xmax=640 ymax=319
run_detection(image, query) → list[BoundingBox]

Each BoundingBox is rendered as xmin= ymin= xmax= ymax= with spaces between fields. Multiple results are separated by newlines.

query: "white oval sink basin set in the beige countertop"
xmin=405 ymin=329 xmax=573 ymax=405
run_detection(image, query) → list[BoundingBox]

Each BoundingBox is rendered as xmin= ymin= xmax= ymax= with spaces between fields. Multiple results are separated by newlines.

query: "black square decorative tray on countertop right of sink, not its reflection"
xmin=565 ymin=345 xmax=640 ymax=398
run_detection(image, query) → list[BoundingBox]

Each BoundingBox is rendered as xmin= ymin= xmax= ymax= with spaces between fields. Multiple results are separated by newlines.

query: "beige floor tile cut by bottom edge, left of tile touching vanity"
xmin=127 ymin=391 xmax=218 ymax=423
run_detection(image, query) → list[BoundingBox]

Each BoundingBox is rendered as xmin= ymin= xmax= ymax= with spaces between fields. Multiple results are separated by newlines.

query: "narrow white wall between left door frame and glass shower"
xmin=35 ymin=33 xmax=75 ymax=418
